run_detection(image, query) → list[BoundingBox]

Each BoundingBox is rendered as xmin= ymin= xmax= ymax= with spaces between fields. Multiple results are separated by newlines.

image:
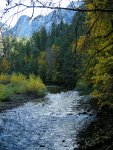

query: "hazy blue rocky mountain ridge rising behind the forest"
xmin=5 ymin=1 xmax=81 ymax=38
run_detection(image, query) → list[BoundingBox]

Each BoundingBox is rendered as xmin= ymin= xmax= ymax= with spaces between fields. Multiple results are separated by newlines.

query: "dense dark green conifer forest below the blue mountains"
xmin=0 ymin=13 xmax=84 ymax=86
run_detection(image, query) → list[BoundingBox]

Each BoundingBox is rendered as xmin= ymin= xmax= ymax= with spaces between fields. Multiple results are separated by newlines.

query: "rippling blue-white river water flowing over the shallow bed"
xmin=0 ymin=91 xmax=92 ymax=150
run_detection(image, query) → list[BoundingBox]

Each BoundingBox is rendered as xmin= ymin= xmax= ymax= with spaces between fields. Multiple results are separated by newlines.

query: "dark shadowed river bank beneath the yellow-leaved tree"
xmin=78 ymin=100 xmax=113 ymax=150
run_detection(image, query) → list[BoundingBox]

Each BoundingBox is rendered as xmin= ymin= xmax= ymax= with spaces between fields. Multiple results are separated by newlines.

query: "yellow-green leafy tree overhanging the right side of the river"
xmin=77 ymin=0 xmax=113 ymax=106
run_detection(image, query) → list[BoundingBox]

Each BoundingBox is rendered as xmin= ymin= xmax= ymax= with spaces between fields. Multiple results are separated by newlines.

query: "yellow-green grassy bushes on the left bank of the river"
xmin=0 ymin=73 xmax=46 ymax=101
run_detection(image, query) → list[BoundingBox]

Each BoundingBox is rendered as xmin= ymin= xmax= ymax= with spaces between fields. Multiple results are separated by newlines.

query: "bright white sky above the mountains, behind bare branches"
xmin=0 ymin=0 xmax=71 ymax=27
